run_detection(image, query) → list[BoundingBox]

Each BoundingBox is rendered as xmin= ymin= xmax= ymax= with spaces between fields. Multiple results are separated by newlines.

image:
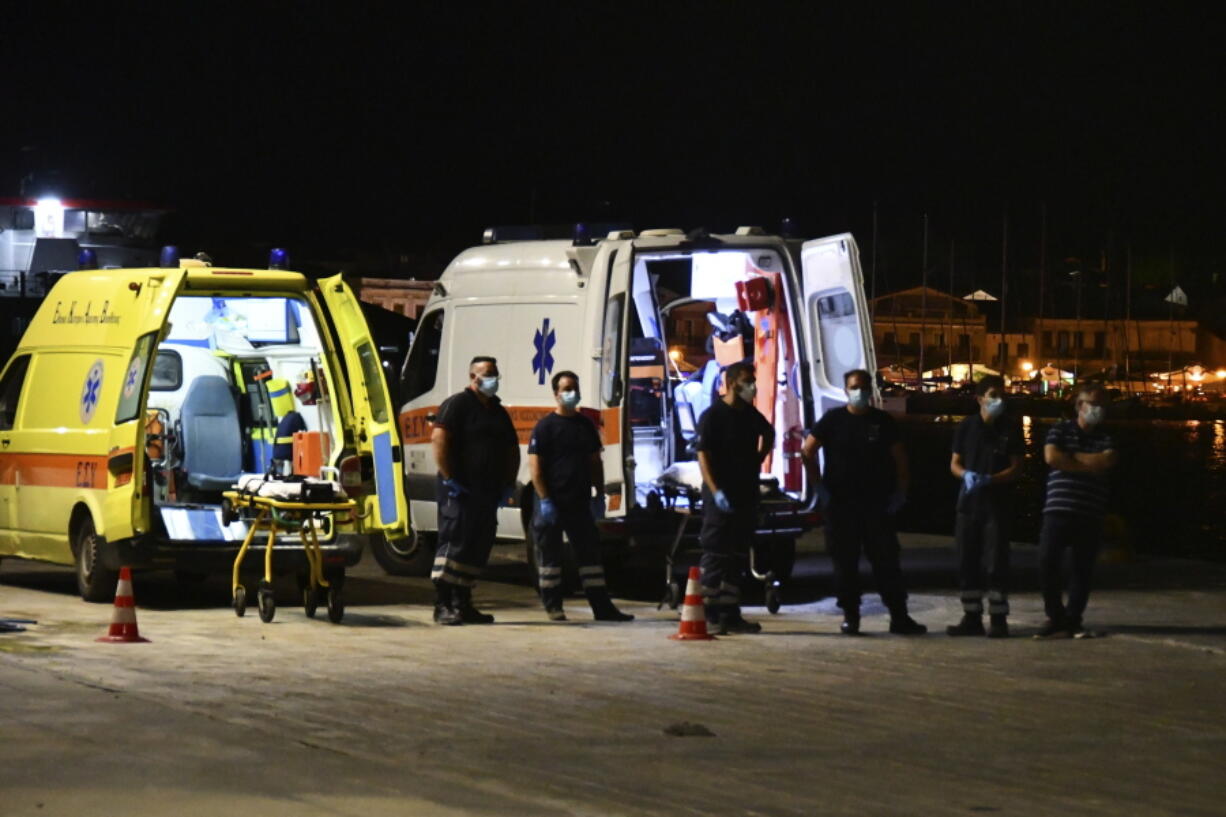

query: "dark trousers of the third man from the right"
xmin=825 ymin=498 xmax=907 ymax=616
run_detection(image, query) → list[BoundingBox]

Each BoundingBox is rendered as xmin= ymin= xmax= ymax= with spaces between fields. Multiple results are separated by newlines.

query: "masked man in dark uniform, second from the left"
xmin=528 ymin=372 xmax=634 ymax=621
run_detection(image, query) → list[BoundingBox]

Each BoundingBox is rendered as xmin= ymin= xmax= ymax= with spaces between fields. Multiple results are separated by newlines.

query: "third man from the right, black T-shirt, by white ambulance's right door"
xmin=803 ymin=369 xmax=928 ymax=635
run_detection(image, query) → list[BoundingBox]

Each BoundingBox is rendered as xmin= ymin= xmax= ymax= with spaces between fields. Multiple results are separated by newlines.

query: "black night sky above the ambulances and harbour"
xmin=0 ymin=2 xmax=1226 ymax=295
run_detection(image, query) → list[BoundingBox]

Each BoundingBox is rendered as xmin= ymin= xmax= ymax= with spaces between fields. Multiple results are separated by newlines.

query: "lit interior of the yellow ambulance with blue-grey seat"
xmin=146 ymin=296 xmax=337 ymax=539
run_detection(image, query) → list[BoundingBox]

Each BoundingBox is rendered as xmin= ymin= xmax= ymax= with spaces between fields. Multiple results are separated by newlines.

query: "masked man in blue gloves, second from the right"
xmin=945 ymin=374 xmax=1025 ymax=638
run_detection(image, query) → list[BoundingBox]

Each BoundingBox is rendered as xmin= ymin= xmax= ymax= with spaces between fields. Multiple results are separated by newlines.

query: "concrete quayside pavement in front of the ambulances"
xmin=0 ymin=534 xmax=1226 ymax=817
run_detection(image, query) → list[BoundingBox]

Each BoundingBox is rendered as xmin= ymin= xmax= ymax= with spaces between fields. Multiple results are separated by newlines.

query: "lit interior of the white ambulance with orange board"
xmin=626 ymin=249 xmax=804 ymax=508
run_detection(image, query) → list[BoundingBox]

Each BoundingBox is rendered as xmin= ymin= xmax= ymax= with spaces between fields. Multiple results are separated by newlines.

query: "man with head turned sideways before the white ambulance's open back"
xmin=698 ymin=363 xmax=775 ymax=634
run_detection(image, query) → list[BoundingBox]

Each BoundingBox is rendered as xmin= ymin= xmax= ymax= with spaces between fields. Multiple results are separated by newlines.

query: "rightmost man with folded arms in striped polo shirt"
xmin=1037 ymin=383 xmax=1117 ymax=638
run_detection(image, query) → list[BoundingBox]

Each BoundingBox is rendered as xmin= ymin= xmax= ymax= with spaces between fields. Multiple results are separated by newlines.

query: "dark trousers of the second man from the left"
xmin=532 ymin=499 xmax=608 ymax=610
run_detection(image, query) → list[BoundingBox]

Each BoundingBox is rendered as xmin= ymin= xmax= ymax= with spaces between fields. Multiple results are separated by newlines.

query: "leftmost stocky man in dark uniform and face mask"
xmin=430 ymin=357 xmax=520 ymax=624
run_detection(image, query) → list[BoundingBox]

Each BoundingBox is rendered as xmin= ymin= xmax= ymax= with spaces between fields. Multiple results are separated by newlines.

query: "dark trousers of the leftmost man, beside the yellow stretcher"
xmin=430 ymin=485 xmax=501 ymax=588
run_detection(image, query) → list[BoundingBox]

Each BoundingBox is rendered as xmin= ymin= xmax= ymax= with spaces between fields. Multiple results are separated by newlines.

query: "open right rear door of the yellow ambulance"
xmin=319 ymin=275 xmax=408 ymax=539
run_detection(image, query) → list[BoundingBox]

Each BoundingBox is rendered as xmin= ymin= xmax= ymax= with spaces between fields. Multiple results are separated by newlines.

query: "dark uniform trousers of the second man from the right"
xmin=954 ymin=488 xmax=1013 ymax=616
